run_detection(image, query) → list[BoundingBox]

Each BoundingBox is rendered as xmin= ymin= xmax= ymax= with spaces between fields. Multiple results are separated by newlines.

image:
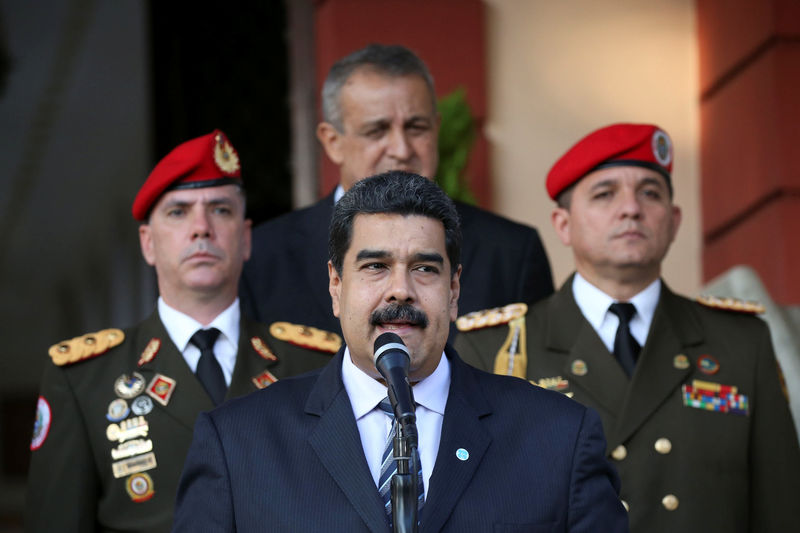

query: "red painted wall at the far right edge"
xmin=697 ymin=0 xmax=800 ymax=305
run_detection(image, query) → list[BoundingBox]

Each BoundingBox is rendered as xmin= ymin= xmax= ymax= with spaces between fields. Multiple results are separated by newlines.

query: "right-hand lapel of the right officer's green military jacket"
xmin=609 ymin=282 xmax=703 ymax=444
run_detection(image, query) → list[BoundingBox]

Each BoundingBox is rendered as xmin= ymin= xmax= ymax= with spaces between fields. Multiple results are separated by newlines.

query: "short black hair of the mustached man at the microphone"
xmin=328 ymin=170 xmax=461 ymax=276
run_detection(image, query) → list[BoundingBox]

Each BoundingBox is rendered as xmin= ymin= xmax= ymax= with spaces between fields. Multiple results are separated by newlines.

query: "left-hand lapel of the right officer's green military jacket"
xmin=545 ymin=277 xmax=628 ymax=413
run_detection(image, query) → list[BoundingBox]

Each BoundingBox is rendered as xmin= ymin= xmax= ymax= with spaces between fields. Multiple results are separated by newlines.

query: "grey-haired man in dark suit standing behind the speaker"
xmin=240 ymin=45 xmax=553 ymax=332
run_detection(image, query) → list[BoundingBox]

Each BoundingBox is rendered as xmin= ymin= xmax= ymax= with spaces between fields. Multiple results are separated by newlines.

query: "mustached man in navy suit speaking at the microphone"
xmin=175 ymin=171 xmax=627 ymax=533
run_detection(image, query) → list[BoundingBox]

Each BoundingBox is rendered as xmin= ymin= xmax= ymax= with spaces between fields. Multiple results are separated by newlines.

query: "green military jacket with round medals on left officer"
xmin=26 ymin=311 xmax=341 ymax=533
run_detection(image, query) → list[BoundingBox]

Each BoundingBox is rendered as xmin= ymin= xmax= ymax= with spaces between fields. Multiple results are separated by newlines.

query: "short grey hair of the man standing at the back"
xmin=322 ymin=44 xmax=436 ymax=132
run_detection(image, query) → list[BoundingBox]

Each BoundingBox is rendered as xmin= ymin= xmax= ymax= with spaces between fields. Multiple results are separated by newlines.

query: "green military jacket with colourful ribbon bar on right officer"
xmin=455 ymin=278 xmax=800 ymax=533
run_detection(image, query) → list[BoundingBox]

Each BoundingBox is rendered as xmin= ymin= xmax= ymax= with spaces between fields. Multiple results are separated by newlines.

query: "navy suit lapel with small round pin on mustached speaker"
xmin=421 ymin=346 xmax=491 ymax=531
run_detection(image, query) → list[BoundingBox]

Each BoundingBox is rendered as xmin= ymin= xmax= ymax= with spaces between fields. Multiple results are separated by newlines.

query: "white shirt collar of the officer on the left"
xmin=158 ymin=296 xmax=241 ymax=387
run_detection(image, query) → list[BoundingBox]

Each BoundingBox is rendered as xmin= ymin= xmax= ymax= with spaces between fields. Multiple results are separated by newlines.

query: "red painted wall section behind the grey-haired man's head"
xmin=314 ymin=0 xmax=491 ymax=206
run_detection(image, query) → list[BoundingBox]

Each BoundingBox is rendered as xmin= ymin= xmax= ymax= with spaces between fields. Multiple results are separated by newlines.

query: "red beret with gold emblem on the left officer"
xmin=132 ymin=130 xmax=242 ymax=221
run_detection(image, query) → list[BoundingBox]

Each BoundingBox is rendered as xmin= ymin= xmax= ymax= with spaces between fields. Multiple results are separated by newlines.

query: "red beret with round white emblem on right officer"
xmin=546 ymin=124 xmax=672 ymax=200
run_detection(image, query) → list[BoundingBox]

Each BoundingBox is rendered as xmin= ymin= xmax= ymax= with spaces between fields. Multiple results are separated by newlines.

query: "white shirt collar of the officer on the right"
xmin=572 ymin=273 xmax=661 ymax=353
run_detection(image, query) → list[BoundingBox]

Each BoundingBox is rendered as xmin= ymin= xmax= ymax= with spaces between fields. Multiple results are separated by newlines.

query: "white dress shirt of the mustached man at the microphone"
xmin=342 ymin=348 xmax=450 ymax=498
